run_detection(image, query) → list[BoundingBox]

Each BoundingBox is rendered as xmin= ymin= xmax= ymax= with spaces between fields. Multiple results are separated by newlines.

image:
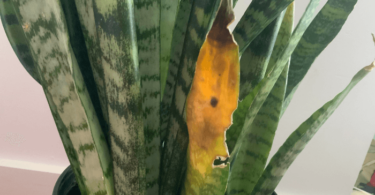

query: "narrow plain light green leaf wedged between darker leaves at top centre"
xmin=160 ymin=0 xmax=181 ymax=99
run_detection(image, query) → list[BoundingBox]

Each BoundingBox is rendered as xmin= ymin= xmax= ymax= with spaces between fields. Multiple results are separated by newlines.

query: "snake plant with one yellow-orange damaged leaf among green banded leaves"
xmin=0 ymin=0 xmax=375 ymax=195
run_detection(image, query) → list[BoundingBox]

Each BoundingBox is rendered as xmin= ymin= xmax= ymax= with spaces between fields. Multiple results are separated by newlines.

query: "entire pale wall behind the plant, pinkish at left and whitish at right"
xmin=0 ymin=0 xmax=375 ymax=195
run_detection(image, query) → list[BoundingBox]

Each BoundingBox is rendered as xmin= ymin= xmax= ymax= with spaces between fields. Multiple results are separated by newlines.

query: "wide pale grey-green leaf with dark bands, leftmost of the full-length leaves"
xmin=8 ymin=0 xmax=114 ymax=194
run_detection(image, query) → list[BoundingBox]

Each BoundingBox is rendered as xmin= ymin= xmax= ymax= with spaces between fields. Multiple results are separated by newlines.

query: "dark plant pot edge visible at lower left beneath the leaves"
xmin=52 ymin=165 xmax=81 ymax=195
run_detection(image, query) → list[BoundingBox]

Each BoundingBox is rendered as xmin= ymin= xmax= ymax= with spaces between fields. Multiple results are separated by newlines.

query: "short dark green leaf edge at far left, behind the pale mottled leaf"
xmin=0 ymin=0 xmax=40 ymax=84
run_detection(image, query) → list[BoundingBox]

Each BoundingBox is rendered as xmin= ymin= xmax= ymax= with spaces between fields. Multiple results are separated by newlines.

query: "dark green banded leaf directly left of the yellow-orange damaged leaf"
xmin=161 ymin=0 xmax=220 ymax=194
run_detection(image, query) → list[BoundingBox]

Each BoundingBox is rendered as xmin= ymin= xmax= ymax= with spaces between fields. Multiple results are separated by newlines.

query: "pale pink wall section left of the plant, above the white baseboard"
xmin=0 ymin=19 xmax=69 ymax=166
